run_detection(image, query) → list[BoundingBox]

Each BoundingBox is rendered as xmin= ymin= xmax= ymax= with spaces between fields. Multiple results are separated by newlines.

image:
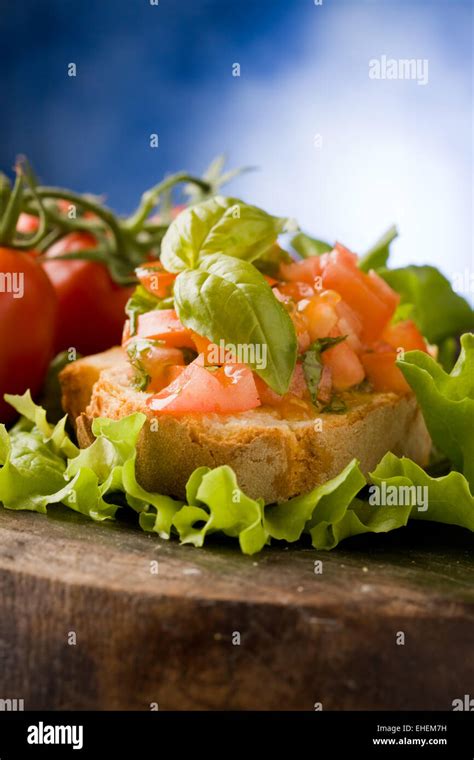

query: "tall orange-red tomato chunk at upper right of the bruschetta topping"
xmin=322 ymin=251 xmax=396 ymax=343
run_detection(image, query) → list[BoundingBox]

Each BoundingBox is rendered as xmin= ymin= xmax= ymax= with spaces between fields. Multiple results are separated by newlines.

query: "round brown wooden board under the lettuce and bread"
xmin=0 ymin=508 xmax=474 ymax=710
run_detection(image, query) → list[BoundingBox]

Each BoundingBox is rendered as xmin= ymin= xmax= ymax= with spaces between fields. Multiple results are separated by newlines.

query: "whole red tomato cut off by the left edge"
xmin=0 ymin=248 xmax=57 ymax=422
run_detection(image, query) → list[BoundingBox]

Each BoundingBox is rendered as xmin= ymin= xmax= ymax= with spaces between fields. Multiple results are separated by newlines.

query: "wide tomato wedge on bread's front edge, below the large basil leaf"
xmin=147 ymin=356 xmax=261 ymax=414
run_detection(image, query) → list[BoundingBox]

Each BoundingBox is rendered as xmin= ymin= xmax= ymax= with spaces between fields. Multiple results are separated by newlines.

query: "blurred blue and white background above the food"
xmin=0 ymin=0 xmax=472 ymax=290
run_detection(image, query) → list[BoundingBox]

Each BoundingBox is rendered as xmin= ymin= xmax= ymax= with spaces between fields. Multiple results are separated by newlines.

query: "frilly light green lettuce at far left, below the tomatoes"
xmin=0 ymin=404 xmax=181 ymax=538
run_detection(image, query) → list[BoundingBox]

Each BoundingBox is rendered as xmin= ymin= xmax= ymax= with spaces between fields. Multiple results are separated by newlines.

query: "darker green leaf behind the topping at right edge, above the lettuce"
xmin=378 ymin=266 xmax=474 ymax=343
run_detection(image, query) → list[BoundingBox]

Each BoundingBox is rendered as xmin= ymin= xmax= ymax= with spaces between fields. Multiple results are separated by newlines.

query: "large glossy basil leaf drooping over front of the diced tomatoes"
xmin=174 ymin=254 xmax=297 ymax=394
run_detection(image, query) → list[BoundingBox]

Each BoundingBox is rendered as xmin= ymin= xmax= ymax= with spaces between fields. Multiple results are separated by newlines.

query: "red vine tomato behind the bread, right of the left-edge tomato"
xmin=43 ymin=232 xmax=133 ymax=354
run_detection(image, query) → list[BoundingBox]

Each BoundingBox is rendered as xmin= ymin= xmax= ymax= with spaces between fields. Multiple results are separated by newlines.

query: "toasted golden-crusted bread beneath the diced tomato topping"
xmin=60 ymin=352 xmax=431 ymax=503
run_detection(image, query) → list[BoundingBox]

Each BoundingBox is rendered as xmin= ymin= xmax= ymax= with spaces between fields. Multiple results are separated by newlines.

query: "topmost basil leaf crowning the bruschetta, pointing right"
xmin=161 ymin=195 xmax=292 ymax=272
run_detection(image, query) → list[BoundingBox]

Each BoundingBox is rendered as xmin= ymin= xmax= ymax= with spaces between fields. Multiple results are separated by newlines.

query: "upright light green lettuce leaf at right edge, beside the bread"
xmin=397 ymin=333 xmax=474 ymax=492
